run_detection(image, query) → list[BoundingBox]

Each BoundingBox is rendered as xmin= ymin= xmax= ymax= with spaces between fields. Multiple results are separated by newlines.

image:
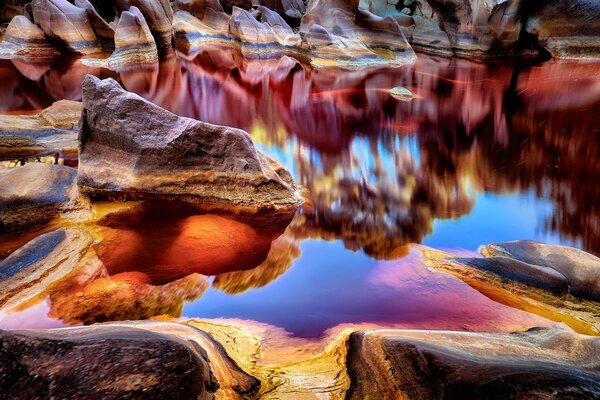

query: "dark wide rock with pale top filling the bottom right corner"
xmin=347 ymin=328 xmax=600 ymax=399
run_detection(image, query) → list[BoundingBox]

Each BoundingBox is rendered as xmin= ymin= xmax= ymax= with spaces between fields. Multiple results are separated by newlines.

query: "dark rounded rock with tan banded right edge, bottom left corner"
xmin=0 ymin=322 xmax=259 ymax=399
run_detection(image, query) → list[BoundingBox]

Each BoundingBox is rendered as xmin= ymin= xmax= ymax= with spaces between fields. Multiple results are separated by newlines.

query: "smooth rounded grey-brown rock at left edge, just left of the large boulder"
xmin=0 ymin=163 xmax=88 ymax=233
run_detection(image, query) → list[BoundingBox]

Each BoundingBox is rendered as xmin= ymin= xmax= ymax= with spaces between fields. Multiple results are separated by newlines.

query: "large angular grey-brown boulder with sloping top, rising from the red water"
xmin=78 ymin=75 xmax=300 ymax=213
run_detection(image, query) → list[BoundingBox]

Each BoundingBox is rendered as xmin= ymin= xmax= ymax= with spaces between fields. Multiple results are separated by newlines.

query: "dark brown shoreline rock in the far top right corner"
xmin=525 ymin=0 xmax=600 ymax=59
